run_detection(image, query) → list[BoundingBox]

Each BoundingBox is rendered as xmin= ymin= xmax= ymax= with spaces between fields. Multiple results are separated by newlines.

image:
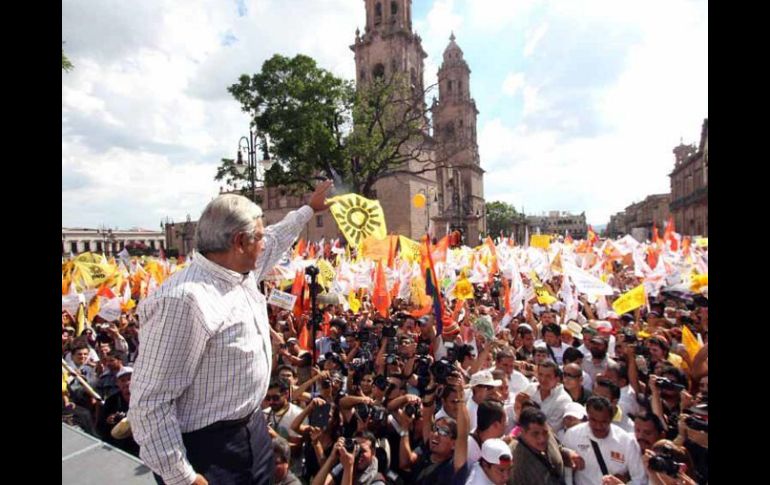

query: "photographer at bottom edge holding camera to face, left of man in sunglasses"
xmin=312 ymin=432 xmax=386 ymax=485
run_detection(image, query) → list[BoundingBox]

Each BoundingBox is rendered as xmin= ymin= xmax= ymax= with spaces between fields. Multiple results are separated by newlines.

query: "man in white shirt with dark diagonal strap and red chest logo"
xmin=562 ymin=396 xmax=647 ymax=485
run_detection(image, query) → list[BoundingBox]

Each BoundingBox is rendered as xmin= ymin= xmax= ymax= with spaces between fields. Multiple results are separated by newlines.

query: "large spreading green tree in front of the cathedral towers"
xmin=215 ymin=54 xmax=450 ymax=197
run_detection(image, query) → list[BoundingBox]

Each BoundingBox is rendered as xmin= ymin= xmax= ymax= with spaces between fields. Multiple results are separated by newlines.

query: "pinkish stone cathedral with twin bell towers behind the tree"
xmin=350 ymin=0 xmax=486 ymax=242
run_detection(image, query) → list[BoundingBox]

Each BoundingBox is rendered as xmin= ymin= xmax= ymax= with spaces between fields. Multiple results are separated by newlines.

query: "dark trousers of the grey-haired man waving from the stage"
xmin=154 ymin=409 xmax=275 ymax=485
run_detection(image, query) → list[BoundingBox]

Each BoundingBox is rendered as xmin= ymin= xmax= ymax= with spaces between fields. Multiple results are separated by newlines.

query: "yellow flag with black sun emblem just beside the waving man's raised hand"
xmin=326 ymin=194 xmax=387 ymax=248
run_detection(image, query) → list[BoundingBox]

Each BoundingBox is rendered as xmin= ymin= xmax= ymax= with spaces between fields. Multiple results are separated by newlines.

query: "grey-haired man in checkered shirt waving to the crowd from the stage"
xmin=128 ymin=181 xmax=332 ymax=485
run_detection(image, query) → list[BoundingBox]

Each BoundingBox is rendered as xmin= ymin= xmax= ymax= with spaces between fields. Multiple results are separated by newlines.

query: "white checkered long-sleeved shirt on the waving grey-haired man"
xmin=128 ymin=206 xmax=313 ymax=485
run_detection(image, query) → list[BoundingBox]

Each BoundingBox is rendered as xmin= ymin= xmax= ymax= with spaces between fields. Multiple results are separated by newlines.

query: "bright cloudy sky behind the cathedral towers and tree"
xmin=62 ymin=0 xmax=708 ymax=229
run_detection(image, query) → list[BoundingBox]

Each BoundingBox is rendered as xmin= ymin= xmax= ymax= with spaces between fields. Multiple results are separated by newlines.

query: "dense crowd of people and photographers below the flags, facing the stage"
xmin=62 ymin=239 xmax=708 ymax=485
